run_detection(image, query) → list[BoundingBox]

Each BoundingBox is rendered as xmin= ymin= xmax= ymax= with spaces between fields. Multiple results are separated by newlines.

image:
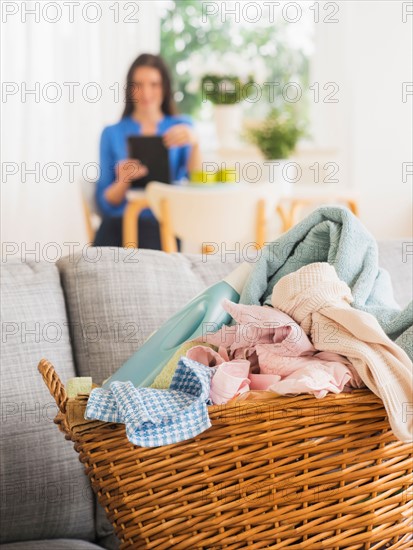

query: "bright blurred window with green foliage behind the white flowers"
xmin=160 ymin=0 xmax=314 ymax=120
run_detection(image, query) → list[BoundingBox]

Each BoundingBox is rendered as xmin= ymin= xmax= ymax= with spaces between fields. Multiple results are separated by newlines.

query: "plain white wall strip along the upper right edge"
xmin=348 ymin=2 xmax=413 ymax=238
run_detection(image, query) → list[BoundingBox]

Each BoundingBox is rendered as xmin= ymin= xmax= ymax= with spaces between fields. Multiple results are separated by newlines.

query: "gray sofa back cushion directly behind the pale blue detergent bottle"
xmin=57 ymin=247 xmax=234 ymax=384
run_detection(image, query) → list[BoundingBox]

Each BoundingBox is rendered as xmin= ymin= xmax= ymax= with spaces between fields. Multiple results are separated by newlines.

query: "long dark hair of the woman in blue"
xmin=122 ymin=53 xmax=177 ymax=118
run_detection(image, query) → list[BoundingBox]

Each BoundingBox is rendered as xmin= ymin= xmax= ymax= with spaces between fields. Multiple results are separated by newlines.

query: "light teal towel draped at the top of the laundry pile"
xmin=239 ymin=206 xmax=413 ymax=359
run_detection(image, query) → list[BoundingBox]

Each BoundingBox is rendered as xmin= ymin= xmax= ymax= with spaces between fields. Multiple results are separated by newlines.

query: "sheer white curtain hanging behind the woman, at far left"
xmin=1 ymin=1 xmax=160 ymax=260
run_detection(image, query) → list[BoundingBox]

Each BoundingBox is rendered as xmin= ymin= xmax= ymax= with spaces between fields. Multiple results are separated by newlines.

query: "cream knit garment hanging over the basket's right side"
xmin=271 ymin=263 xmax=413 ymax=443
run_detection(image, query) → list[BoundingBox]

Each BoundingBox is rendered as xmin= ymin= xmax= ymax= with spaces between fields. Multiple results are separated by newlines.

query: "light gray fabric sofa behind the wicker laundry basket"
xmin=0 ymin=244 xmax=413 ymax=550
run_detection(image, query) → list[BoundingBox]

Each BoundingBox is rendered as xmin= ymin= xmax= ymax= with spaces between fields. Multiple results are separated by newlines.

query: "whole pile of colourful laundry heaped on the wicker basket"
xmin=85 ymin=207 xmax=413 ymax=446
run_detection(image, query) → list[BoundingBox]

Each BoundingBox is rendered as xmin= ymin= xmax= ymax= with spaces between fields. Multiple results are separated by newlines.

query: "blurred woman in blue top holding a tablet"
xmin=94 ymin=54 xmax=201 ymax=250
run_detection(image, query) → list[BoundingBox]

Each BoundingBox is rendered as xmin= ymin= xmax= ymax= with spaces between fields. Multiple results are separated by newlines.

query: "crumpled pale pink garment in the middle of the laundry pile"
xmin=187 ymin=299 xmax=363 ymax=403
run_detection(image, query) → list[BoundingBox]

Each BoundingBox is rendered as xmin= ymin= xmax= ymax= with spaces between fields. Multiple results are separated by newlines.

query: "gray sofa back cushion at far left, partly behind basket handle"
xmin=0 ymin=262 xmax=95 ymax=548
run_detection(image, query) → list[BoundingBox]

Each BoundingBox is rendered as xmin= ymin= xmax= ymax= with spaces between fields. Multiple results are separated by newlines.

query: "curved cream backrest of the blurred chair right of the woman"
xmin=146 ymin=182 xmax=281 ymax=253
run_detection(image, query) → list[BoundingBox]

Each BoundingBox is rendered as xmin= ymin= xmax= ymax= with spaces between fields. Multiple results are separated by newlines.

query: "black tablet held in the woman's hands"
xmin=128 ymin=136 xmax=171 ymax=189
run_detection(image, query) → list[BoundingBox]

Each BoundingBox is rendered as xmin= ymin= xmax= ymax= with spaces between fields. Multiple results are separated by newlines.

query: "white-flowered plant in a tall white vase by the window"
xmin=187 ymin=52 xmax=265 ymax=147
